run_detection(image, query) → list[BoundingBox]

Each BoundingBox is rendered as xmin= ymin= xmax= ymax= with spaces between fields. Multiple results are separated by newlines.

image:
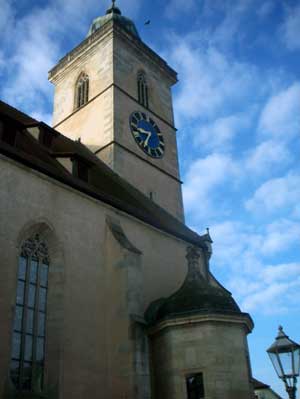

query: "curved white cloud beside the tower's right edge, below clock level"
xmin=183 ymin=153 xmax=239 ymax=217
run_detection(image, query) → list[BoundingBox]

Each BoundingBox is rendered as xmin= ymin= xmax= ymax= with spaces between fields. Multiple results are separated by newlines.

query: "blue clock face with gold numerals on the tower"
xmin=129 ymin=111 xmax=165 ymax=158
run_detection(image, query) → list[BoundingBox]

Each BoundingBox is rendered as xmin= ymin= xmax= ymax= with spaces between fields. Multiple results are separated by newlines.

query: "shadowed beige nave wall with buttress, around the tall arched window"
xmin=0 ymin=157 xmax=186 ymax=399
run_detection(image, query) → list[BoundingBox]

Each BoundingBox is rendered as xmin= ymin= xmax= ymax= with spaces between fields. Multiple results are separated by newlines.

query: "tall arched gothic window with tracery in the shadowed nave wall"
xmin=10 ymin=234 xmax=49 ymax=392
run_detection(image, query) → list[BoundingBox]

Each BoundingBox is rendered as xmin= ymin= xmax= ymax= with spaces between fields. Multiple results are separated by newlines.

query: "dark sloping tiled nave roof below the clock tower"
xmin=0 ymin=101 xmax=206 ymax=247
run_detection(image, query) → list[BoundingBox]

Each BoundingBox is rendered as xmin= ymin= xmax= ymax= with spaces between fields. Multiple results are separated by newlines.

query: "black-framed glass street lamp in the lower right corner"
xmin=267 ymin=326 xmax=300 ymax=399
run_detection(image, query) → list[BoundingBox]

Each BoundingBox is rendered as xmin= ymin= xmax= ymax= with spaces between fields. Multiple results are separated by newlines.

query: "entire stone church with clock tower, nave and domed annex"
xmin=0 ymin=1 xmax=254 ymax=399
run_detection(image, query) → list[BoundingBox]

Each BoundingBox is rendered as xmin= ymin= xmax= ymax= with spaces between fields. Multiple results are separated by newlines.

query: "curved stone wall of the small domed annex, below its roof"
xmin=151 ymin=315 xmax=253 ymax=399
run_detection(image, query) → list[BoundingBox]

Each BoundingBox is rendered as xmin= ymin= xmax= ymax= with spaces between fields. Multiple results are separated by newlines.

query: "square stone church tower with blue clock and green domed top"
xmin=49 ymin=1 xmax=184 ymax=221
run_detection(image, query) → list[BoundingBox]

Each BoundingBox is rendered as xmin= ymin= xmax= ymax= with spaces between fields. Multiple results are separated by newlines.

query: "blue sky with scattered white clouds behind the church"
xmin=0 ymin=0 xmax=300 ymax=394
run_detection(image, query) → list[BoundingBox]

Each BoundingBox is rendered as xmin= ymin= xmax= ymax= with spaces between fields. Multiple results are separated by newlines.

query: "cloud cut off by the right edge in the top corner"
xmin=282 ymin=6 xmax=300 ymax=50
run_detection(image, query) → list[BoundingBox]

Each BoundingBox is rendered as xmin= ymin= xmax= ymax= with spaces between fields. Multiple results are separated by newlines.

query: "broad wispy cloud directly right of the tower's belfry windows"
xmin=167 ymin=38 xmax=256 ymax=124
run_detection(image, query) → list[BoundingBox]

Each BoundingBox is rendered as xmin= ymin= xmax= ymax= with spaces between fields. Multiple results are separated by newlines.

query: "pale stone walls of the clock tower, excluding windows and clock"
xmin=51 ymin=26 xmax=184 ymax=221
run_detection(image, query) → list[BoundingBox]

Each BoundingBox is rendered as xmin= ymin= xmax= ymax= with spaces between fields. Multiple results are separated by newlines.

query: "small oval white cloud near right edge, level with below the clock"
xmin=245 ymin=140 xmax=292 ymax=175
